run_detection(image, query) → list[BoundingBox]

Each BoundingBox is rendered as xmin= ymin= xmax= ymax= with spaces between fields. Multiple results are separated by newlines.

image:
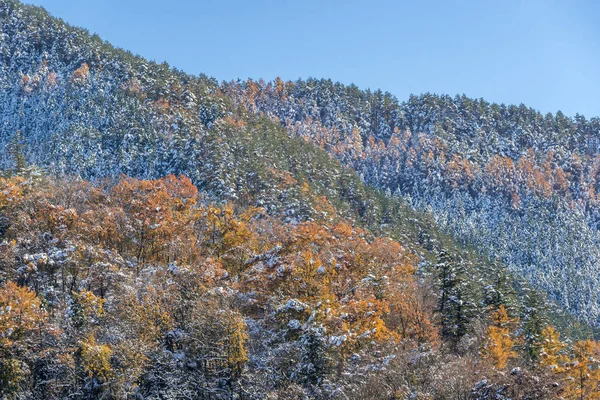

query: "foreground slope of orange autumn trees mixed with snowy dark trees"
xmin=0 ymin=171 xmax=600 ymax=399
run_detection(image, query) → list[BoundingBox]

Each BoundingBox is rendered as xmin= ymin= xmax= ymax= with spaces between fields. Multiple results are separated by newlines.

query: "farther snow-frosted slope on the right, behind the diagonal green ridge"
xmin=223 ymin=79 xmax=600 ymax=324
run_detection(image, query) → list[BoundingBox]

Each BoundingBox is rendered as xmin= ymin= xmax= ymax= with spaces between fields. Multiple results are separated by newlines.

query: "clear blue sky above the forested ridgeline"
xmin=26 ymin=0 xmax=600 ymax=117
